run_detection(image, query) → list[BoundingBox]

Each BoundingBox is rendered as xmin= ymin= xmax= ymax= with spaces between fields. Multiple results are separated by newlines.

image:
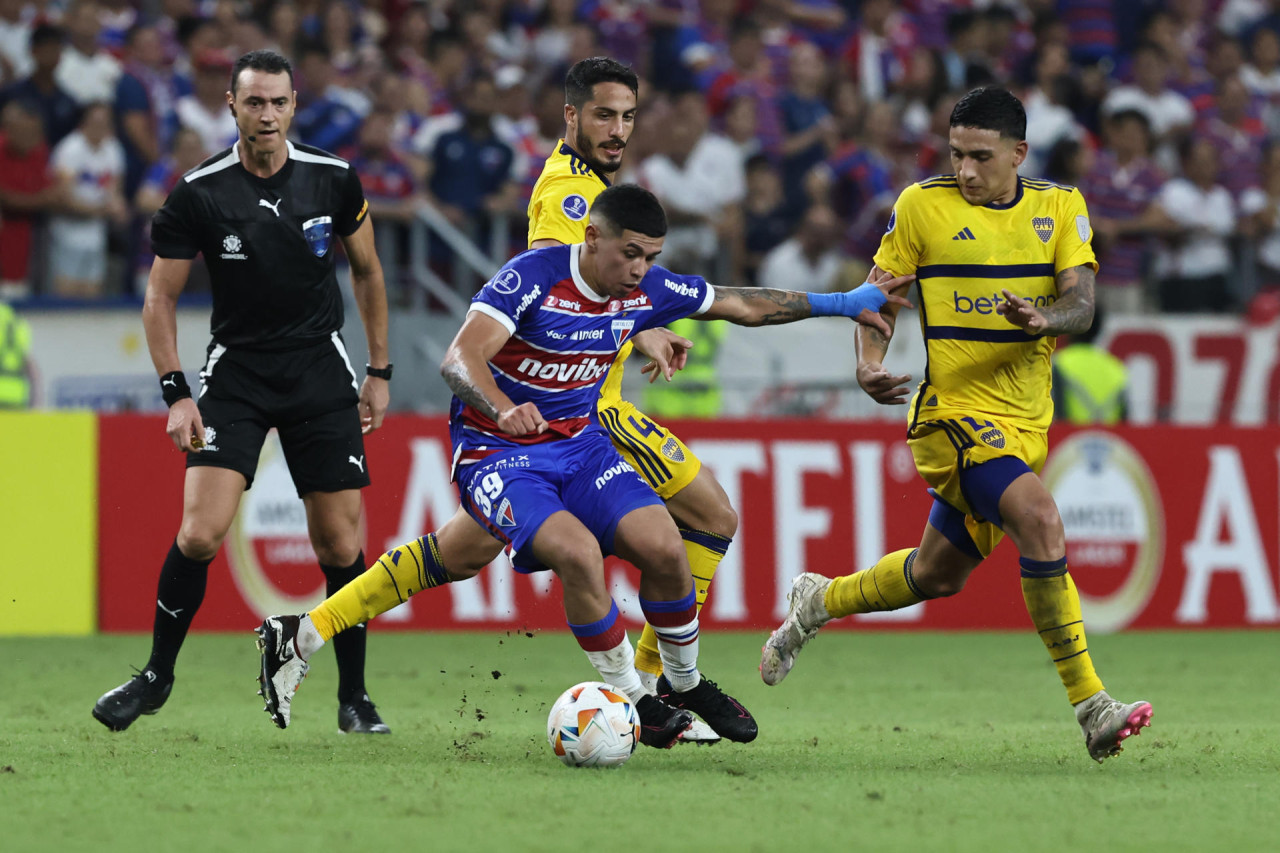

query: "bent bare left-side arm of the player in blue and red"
xmin=440 ymin=311 xmax=547 ymax=435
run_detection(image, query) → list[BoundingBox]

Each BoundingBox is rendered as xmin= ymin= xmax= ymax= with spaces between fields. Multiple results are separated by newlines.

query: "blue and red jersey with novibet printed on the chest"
xmin=451 ymin=245 xmax=713 ymax=465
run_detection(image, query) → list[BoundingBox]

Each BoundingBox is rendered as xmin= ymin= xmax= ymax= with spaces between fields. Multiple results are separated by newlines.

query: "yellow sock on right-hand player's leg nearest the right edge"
xmin=1019 ymin=557 xmax=1102 ymax=704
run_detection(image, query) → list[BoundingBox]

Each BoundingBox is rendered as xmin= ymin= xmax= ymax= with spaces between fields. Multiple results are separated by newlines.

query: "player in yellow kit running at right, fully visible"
xmin=760 ymin=87 xmax=1152 ymax=762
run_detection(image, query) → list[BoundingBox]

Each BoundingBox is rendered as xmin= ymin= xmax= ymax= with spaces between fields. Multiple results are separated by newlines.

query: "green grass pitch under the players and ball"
xmin=0 ymin=630 xmax=1280 ymax=853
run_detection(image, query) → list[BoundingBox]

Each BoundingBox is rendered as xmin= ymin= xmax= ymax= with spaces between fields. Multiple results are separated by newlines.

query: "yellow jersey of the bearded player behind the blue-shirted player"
xmin=529 ymin=140 xmax=634 ymax=409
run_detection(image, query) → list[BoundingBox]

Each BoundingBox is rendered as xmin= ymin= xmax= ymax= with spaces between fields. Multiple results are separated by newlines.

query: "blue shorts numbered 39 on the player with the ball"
xmin=458 ymin=427 xmax=662 ymax=573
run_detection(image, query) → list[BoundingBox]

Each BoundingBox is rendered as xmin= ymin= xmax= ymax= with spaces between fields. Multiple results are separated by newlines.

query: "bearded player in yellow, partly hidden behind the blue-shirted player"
xmin=252 ymin=56 xmax=737 ymax=743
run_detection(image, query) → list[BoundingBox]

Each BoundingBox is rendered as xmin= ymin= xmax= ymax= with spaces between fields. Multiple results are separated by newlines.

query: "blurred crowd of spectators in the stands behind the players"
xmin=0 ymin=0 xmax=1280 ymax=313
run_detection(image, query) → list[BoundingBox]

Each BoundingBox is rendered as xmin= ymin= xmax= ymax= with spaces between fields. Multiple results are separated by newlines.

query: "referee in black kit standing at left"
xmin=93 ymin=50 xmax=392 ymax=734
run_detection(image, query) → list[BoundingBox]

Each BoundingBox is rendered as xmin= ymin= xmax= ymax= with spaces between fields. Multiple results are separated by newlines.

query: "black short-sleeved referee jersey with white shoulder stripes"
xmin=151 ymin=142 xmax=369 ymax=350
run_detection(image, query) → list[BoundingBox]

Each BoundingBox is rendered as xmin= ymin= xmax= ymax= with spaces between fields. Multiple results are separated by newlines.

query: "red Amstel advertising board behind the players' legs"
xmin=99 ymin=415 xmax=1280 ymax=631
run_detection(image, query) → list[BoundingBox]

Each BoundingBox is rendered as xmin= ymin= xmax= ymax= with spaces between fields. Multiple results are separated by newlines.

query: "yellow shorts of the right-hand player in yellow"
xmin=906 ymin=418 xmax=1048 ymax=557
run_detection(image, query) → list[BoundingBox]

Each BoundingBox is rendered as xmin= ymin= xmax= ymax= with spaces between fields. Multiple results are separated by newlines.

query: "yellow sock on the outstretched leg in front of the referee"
xmin=310 ymin=533 xmax=451 ymax=643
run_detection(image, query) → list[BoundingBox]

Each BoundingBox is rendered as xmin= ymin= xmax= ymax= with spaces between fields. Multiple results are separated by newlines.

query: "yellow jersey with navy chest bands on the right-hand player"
xmin=874 ymin=175 xmax=1097 ymax=432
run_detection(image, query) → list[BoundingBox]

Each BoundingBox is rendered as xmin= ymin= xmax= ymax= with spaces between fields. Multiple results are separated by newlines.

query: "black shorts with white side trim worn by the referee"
xmin=187 ymin=332 xmax=369 ymax=497
